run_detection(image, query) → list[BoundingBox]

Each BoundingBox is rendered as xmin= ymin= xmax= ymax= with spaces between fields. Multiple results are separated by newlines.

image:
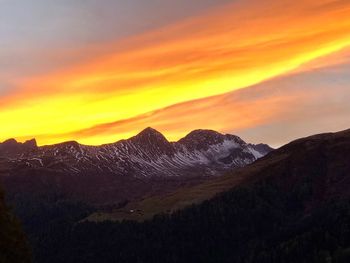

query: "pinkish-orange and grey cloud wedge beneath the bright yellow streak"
xmin=21 ymin=58 xmax=350 ymax=147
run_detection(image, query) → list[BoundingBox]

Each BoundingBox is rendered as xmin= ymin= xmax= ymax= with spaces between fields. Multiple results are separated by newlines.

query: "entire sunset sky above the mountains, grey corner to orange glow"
xmin=0 ymin=0 xmax=350 ymax=147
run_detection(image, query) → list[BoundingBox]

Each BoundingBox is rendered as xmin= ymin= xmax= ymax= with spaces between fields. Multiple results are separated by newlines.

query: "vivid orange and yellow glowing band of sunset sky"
xmin=0 ymin=0 xmax=350 ymax=144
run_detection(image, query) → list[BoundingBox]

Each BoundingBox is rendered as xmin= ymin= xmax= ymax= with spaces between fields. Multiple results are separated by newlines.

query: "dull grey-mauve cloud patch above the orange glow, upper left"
xmin=0 ymin=0 xmax=230 ymax=77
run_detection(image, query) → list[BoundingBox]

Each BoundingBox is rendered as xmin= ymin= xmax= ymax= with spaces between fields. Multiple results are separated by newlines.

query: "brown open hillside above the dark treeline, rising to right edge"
xmin=89 ymin=130 xmax=350 ymax=221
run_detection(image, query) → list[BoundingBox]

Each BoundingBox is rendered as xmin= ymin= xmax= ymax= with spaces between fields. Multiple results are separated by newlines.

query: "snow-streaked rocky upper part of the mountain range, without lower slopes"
xmin=0 ymin=128 xmax=271 ymax=178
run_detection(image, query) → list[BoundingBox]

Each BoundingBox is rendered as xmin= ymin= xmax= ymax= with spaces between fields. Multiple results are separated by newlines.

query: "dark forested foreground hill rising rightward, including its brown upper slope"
xmin=17 ymin=131 xmax=350 ymax=263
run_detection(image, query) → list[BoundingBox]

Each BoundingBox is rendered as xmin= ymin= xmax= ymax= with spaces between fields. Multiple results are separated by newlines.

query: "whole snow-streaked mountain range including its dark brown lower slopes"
xmin=0 ymin=128 xmax=272 ymax=203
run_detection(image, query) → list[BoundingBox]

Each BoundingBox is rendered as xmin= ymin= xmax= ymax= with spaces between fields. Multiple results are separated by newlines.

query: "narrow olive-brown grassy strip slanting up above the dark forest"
xmin=87 ymin=152 xmax=285 ymax=222
